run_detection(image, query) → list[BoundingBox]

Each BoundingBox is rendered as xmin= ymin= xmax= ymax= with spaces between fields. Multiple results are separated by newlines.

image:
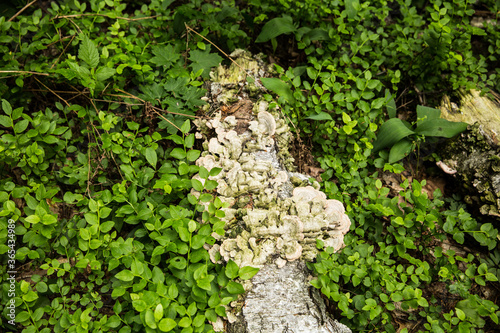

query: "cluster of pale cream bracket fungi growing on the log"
xmin=193 ymin=107 xmax=351 ymax=267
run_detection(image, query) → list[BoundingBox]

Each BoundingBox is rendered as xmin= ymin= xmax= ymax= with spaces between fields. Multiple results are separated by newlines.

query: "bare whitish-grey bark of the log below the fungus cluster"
xmin=227 ymin=262 xmax=351 ymax=333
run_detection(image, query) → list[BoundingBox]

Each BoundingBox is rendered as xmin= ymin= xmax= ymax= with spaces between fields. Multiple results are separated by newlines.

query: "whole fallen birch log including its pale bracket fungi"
xmin=193 ymin=52 xmax=351 ymax=333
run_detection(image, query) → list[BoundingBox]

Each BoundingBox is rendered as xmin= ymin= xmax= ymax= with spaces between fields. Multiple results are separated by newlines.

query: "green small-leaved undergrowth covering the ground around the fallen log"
xmin=0 ymin=0 xmax=500 ymax=333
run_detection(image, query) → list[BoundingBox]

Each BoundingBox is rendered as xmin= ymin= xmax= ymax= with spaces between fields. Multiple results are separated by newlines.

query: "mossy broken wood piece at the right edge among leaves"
xmin=440 ymin=91 xmax=500 ymax=217
